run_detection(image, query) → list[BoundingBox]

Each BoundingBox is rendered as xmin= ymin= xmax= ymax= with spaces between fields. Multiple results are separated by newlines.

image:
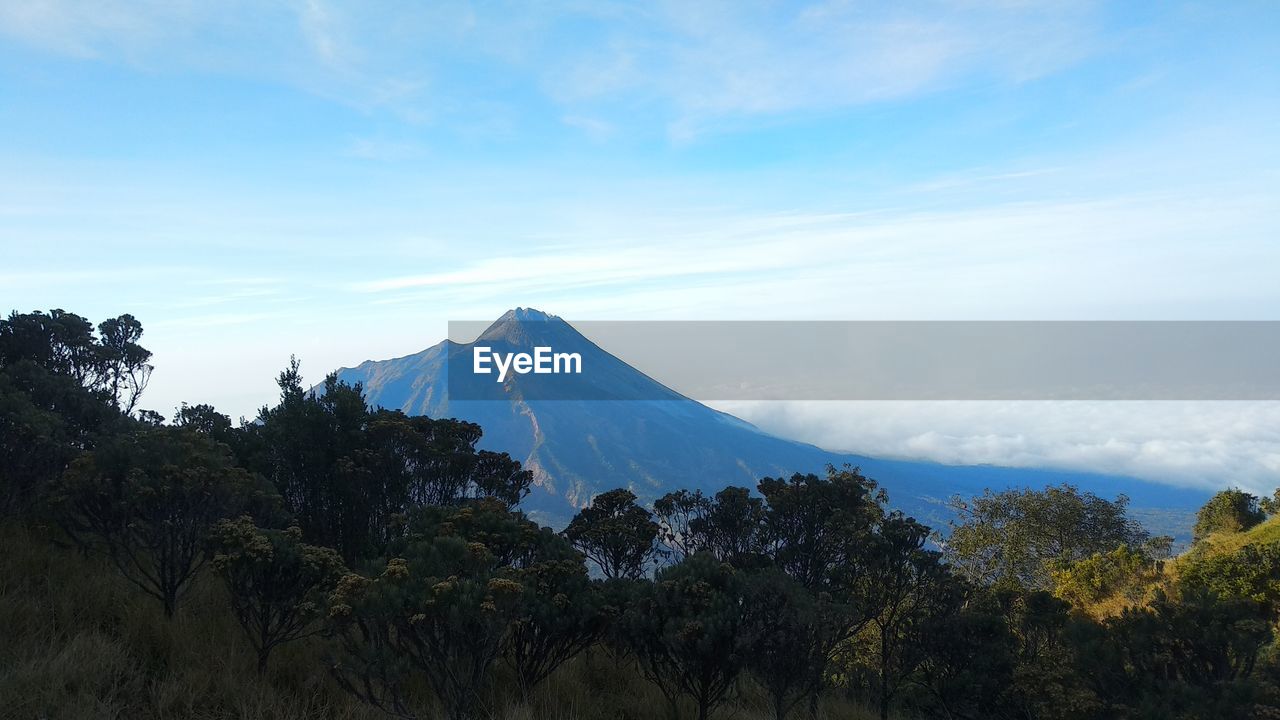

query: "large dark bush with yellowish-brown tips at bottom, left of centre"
xmin=329 ymin=500 xmax=542 ymax=720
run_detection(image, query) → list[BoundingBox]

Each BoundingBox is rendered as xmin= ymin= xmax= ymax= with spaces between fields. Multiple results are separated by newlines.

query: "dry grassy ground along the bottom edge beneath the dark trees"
xmin=0 ymin=523 xmax=896 ymax=720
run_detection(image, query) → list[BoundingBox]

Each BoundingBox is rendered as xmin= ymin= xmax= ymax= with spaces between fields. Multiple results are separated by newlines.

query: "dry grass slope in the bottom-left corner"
xmin=0 ymin=525 xmax=380 ymax=720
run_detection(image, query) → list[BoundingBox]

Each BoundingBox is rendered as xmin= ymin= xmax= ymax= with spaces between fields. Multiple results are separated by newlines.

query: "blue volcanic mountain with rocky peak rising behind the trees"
xmin=337 ymin=307 xmax=1208 ymax=539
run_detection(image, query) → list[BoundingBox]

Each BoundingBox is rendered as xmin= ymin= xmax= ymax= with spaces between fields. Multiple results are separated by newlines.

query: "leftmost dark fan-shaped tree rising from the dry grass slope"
xmin=50 ymin=428 xmax=262 ymax=618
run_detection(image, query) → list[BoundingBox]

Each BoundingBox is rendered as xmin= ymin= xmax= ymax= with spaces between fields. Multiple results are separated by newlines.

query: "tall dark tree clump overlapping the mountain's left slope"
xmin=249 ymin=360 xmax=532 ymax=565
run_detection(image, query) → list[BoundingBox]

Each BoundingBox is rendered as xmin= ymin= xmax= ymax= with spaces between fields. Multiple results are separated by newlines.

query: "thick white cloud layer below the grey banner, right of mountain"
xmin=714 ymin=401 xmax=1280 ymax=495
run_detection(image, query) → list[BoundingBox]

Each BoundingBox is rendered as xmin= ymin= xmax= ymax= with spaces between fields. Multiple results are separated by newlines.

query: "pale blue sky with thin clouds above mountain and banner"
xmin=0 ymin=0 xmax=1280 ymax=484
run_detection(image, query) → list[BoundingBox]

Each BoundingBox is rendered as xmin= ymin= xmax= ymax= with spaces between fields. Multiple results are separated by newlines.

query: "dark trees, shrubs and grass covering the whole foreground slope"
xmin=0 ymin=311 xmax=1280 ymax=720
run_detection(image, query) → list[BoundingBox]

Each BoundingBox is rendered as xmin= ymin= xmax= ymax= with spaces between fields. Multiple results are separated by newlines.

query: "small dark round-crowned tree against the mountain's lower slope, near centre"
xmin=564 ymin=488 xmax=658 ymax=580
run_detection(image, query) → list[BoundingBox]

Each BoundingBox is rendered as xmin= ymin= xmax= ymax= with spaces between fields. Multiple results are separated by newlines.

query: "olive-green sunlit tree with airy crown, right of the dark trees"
xmin=946 ymin=484 xmax=1148 ymax=589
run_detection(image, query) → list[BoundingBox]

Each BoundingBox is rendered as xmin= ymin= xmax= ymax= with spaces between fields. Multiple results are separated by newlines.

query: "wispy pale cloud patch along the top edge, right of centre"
xmin=548 ymin=0 xmax=1101 ymax=133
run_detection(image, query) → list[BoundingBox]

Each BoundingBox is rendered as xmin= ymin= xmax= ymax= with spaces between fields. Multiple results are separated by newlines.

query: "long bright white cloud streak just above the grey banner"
xmin=349 ymin=185 xmax=1280 ymax=319
